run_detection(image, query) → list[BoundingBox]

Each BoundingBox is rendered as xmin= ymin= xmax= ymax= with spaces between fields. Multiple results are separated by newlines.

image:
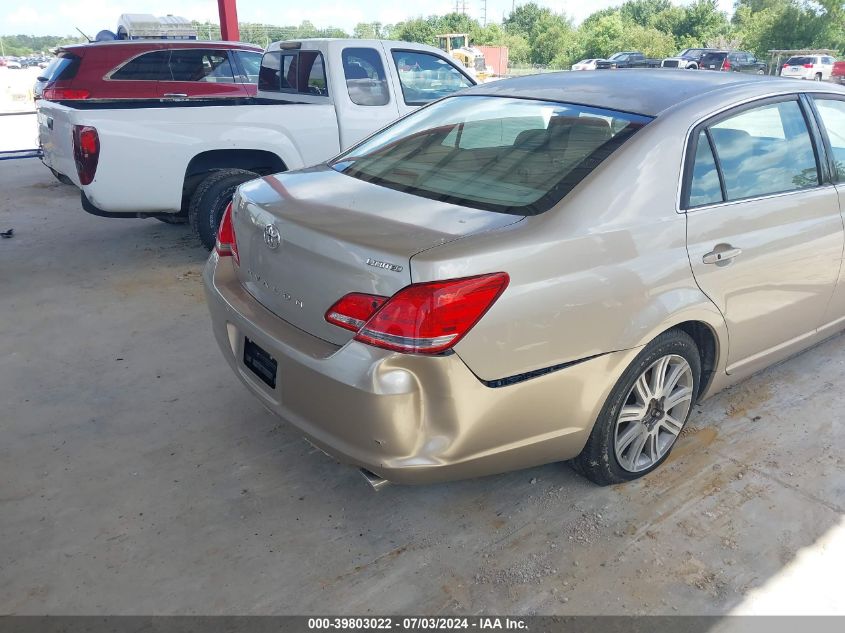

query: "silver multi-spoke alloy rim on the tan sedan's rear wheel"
xmin=613 ymin=354 xmax=694 ymax=473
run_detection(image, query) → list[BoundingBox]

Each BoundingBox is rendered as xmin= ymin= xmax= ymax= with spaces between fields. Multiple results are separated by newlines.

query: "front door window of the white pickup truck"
xmin=393 ymin=50 xmax=473 ymax=105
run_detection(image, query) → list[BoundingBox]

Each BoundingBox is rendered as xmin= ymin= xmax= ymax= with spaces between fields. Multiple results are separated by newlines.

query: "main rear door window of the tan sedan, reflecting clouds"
xmin=710 ymin=101 xmax=820 ymax=200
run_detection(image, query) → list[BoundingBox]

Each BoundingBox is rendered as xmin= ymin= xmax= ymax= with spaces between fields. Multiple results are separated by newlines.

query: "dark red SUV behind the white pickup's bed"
xmin=35 ymin=40 xmax=263 ymax=101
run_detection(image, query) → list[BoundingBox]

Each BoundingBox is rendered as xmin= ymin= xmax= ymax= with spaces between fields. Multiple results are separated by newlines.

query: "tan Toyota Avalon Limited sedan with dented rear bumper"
xmin=204 ymin=70 xmax=845 ymax=484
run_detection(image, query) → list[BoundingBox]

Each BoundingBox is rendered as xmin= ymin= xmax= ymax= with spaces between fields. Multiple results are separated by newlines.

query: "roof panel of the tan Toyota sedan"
xmin=460 ymin=68 xmax=820 ymax=116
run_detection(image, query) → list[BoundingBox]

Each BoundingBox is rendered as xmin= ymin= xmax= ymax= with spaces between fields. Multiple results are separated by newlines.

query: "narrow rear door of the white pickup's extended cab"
xmin=334 ymin=46 xmax=400 ymax=150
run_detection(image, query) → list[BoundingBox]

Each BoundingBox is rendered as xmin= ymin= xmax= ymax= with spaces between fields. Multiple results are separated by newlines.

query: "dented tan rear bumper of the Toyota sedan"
xmin=204 ymin=254 xmax=637 ymax=484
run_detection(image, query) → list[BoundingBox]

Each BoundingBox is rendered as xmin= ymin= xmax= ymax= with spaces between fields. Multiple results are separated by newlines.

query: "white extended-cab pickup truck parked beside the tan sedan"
xmin=38 ymin=39 xmax=475 ymax=248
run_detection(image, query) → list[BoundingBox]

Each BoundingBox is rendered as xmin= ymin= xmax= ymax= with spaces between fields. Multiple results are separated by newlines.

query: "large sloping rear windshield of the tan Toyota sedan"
xmin=332 ymin=96 xmax=651 ymax=215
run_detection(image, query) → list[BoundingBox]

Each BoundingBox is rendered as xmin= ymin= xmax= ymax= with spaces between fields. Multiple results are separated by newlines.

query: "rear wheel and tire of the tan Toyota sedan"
xmin=573 ymin=330 xmax=701 ymax=486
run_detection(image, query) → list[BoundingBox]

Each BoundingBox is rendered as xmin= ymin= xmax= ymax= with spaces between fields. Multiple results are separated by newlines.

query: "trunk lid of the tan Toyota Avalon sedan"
xmin=233 ymin=167 xmax=522 ymax=345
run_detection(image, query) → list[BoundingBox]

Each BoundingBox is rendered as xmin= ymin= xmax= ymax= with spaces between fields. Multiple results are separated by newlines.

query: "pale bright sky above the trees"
xmin=0 ymin=0 xmax=733 ymax=36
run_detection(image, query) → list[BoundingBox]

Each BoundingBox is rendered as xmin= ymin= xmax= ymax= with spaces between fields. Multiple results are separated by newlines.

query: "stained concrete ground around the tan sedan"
xmin=0 ymin=160 xmax=845 ymax=614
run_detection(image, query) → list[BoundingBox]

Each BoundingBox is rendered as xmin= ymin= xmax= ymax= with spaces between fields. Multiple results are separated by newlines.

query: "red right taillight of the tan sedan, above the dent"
xmin=326 ymin=273 xmax=510 ymax=354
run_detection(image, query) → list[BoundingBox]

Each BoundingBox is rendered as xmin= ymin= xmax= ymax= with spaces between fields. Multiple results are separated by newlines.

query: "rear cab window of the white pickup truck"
xmin=258 ymin=51 xmax=329 ymax=96
